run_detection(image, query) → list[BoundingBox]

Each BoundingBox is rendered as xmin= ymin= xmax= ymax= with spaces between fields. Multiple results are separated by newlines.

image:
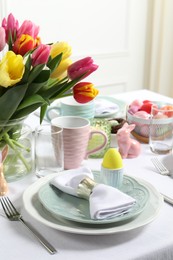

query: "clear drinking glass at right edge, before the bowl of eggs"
xmin=149 ymin=106 xmax=173 ymax=154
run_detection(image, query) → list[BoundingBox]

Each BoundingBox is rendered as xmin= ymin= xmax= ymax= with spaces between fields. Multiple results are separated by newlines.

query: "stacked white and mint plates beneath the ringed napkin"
xmin=23 ymin=172 xmax=163 ymax=235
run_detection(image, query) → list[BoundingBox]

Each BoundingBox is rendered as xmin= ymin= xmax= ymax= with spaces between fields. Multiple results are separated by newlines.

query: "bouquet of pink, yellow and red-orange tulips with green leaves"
xmin=0 ymin=14 xmax=98 ymax=180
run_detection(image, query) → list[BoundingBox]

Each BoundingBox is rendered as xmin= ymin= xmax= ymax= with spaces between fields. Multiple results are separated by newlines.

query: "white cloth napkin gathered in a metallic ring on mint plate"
xmin=50 ymin=167 xmax=136 ymax=219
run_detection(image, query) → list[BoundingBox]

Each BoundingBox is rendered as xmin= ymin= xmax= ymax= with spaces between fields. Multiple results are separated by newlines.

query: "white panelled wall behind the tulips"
xmin=0 ymin=0 xmax=148 ymax=94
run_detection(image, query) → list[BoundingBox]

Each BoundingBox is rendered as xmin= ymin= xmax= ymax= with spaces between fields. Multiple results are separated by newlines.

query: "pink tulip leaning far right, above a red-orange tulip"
xmin=68 ymin=57 xmax=98 ymax=80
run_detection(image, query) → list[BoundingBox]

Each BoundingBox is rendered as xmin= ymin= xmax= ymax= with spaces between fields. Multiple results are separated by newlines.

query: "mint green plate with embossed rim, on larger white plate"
xmin=38 ymin=172 xmax=149 ymax=224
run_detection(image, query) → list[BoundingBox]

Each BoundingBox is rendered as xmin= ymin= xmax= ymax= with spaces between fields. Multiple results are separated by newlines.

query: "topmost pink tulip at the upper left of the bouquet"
xmin=2 ymin=13 xmax=19 ymax=43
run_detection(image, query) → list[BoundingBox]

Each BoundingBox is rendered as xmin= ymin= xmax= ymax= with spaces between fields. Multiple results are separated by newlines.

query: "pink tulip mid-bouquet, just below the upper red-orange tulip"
xmin=31 ymin=44 xmax=51 ymax=67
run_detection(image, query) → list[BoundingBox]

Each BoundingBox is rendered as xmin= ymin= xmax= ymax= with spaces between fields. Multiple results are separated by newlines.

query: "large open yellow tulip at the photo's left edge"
xmin=0 ymin=51 xmax=25 ymax=88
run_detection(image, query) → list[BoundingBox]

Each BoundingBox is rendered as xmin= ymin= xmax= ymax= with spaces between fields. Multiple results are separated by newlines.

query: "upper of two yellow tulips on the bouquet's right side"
xmin=50 ymin=42 xmax=72 ymax=60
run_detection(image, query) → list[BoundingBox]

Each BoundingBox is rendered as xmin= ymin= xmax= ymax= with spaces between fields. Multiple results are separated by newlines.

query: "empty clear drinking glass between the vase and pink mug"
xmin=35 ymin=124 xmax=64 ymax=177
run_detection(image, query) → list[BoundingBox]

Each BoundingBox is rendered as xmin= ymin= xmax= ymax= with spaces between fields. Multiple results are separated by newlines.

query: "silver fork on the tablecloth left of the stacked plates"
xmin=0 ymin=197 xmax=57 ymax=254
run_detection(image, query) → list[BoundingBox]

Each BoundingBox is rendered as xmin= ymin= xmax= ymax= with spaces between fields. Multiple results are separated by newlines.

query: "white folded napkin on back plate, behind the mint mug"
xmin=94 ymin=99 xmax=119 ymax=115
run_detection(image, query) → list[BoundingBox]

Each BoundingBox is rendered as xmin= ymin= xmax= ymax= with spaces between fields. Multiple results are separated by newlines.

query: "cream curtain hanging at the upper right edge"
xmin=144 ymin=0 xmax=173 ymax=97
